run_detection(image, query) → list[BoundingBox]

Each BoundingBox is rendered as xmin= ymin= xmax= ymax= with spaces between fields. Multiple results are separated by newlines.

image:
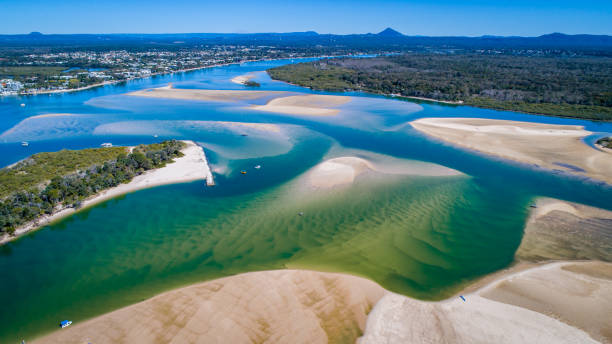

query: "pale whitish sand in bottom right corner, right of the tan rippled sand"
xmin=358 ymin=262 xmax=612 ymax=344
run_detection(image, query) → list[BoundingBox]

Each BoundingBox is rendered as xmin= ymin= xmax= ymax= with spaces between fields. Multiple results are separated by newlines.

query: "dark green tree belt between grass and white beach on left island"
xmin=0 ymin=140 xmax=185 ymax=234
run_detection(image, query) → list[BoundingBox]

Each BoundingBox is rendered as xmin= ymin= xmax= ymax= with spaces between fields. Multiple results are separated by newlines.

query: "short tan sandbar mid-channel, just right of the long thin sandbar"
xmin=251 ymin=94 xmax=351 ymax=116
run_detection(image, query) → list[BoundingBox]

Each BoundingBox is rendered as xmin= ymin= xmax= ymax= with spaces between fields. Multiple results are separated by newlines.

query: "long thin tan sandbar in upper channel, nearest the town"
xmin=127 ymin=85 xmax=286 ymax=102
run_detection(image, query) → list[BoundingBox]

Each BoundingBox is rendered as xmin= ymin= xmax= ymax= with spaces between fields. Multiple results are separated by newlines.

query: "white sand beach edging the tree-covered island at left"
xmin=0 ymin=140 xmax=214 ymax=246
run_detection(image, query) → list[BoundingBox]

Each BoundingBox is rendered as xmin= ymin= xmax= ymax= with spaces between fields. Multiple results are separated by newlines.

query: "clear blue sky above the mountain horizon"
xmin=0 ymin=0 xmax=612 ymax=36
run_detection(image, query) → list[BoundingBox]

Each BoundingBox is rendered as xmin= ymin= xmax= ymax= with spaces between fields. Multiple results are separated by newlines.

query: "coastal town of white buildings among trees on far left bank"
xmin=0 ymin=45 xmax=322 ymax=96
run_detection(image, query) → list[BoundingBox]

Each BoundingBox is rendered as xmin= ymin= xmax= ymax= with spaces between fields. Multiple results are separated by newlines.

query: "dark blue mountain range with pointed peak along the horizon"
xmin=0 ymin=27 xmax=612 ymax=51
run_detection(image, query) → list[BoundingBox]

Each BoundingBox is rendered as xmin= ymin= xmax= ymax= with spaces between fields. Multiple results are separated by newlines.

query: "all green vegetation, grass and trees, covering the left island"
xmin=0 ymin=140 xmax=185 ymax=234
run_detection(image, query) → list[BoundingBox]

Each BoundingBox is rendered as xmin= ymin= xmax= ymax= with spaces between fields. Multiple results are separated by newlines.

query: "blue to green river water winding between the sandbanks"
xmin=0 ymin=61 xmax=612 ymax=343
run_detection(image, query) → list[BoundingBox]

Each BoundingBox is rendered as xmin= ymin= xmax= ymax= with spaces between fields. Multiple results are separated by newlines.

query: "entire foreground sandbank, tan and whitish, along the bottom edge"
xmin=34 ymin=262 xmax=612 ymax=344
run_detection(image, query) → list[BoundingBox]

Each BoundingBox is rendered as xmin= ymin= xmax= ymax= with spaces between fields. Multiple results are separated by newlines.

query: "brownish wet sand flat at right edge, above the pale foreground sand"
xmin=516 ymin=198 xmax=612 ymax=262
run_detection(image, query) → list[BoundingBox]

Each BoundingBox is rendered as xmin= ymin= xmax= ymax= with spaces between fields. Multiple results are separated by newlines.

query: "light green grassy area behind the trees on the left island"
xmin=0 ymin=147 xmax=126 ymax=199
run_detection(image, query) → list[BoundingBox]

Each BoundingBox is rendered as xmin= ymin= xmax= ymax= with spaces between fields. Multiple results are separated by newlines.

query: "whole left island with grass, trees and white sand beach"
xmin=0 ymin=140 xmax=214 ymax=244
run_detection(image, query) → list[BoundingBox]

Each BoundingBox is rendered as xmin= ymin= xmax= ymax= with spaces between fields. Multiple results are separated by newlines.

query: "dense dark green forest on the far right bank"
xmin=268 ymin=53 xmax=612 ymax=120
